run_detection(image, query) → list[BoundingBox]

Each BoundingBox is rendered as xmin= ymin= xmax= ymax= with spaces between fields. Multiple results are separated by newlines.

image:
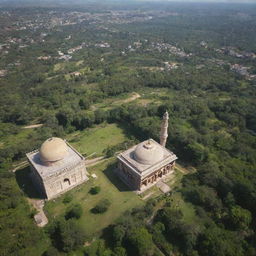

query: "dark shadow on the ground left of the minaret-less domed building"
xmin=15 ymin=167 xmax=45 ymax=199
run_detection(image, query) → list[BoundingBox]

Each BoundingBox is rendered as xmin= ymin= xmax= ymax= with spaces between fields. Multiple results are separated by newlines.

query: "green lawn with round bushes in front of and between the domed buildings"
xmin=45 ymin=159 xmax=144 ymax=238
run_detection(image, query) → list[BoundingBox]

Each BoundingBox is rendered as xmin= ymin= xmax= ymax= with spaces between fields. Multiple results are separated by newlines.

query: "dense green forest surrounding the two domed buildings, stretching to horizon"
xmin=0 ymin=3 xmax=256 ymax=256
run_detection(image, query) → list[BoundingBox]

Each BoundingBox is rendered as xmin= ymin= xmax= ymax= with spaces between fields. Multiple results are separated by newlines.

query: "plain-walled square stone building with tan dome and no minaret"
xmin=26 ymin=137 xmax=88 ymax=199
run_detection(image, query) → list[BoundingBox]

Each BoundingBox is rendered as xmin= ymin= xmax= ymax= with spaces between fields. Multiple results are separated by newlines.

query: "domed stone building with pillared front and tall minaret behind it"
xmin=117 ymin=112 xmax=177 ymax=192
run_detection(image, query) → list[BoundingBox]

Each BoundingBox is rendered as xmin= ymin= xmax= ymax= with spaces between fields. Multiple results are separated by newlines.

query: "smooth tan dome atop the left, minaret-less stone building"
xmin=39 ymin=137 xmax=68 ymax=162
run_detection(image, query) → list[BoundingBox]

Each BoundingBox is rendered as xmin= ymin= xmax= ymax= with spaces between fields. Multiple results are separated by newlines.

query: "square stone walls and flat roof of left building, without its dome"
xmin=27 ymin=138 xmax=88 ymax=199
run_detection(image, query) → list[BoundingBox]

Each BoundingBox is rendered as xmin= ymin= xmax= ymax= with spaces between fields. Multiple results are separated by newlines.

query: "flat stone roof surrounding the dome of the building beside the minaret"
xmin=117 ymin=139 xmax=178 ymax=177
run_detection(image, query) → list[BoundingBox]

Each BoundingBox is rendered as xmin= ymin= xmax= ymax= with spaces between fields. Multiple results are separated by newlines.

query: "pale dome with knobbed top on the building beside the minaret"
xmin=134 ymin=140 xmax=164 ymax=165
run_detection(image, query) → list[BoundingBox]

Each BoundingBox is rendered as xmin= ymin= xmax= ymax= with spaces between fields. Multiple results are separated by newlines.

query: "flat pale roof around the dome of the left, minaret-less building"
xmin=26 ymin=143 xmax=84 ymax=179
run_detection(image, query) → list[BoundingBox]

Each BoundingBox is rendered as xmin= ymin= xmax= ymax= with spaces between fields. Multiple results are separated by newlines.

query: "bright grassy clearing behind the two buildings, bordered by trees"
xmin=68 ymin=124 xmax=127 ymax=156
